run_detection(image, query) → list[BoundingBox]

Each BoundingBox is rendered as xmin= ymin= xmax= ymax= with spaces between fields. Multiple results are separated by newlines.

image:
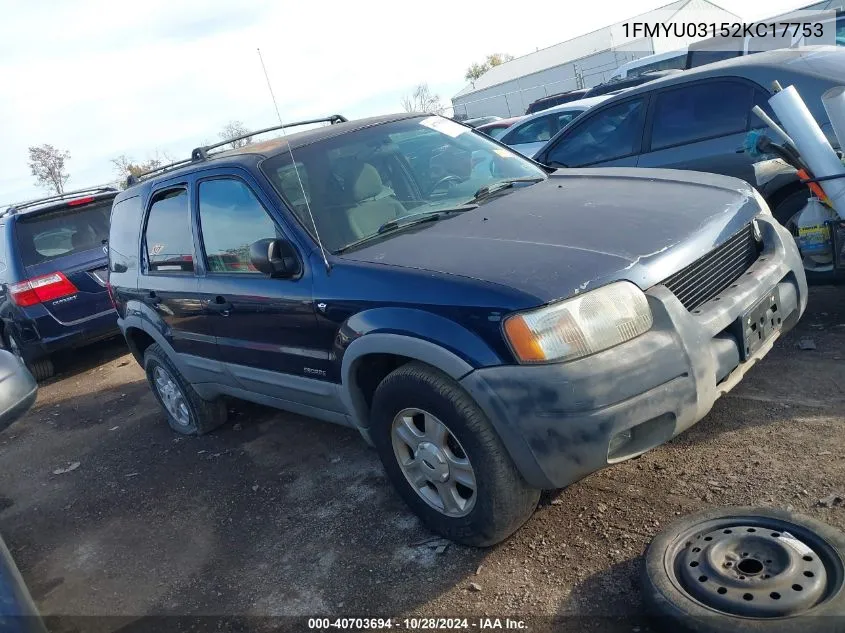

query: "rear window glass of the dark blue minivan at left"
xmin=15 ymin=200 xmax=111 ymax=266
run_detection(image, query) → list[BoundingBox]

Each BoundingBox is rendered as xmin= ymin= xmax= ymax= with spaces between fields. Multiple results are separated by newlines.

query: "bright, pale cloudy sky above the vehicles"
xmin=0 ymin=0 xmax=806 ymax=206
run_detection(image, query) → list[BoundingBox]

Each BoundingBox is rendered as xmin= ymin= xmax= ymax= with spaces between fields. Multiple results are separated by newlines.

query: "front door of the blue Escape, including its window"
xmin=197 ymin=174 xmax=339 ymax=410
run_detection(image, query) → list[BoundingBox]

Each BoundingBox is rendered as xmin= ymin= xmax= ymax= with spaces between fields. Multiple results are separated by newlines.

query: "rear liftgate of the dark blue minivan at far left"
xmin=15 ymin=197 xmax=113 ymax=324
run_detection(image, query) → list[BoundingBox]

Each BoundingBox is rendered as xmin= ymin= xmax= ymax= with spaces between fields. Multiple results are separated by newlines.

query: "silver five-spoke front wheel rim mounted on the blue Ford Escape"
xmin=390 ymin=408 xmax=478 ymax=517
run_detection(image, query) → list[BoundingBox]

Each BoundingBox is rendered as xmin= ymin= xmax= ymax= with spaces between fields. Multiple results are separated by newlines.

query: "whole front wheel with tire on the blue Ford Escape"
xmin=372 ymin=362 xmax=540 ymax=547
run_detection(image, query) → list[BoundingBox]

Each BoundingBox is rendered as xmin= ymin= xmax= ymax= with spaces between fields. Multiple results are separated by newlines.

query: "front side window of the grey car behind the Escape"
xmin=547 ymin=99 xmax=643 ymax=167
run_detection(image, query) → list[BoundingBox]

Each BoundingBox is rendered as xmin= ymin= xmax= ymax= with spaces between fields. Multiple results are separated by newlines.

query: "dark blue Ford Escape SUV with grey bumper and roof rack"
xmin=109 ymin=114 xmax=807 ymax=546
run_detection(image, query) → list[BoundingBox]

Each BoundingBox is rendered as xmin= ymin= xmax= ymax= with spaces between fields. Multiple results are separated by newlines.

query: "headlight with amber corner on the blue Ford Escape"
xmin=504 ymin=281 xmax=653 ymax=363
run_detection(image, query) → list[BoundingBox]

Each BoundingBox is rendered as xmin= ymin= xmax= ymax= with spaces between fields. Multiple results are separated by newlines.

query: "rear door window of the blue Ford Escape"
xmin=144 ymin=189 xmax=194 ymax=273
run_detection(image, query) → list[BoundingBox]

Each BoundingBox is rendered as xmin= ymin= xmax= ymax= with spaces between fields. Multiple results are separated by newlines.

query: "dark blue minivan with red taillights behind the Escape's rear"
xmin=0 ymin=187 xmax=120 ymax=380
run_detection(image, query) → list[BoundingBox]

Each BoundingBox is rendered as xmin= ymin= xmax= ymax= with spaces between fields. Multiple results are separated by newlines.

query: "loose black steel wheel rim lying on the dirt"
xmin=664 ymin=516 xmax=843 ymax=619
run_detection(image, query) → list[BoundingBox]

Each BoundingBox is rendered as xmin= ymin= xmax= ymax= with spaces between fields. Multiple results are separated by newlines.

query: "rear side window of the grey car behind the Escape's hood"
xmin=651 ymin=81 xmax=751 ymax=150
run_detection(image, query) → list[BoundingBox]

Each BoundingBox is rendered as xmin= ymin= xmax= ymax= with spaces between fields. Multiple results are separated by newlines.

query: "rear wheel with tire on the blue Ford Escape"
xmin=144 ymin=343 xmax=228 ymax=435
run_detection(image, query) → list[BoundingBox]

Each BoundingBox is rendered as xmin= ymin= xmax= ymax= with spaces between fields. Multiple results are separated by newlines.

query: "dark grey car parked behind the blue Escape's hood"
xmin=535 ymin=46 xmax=845 ymax=233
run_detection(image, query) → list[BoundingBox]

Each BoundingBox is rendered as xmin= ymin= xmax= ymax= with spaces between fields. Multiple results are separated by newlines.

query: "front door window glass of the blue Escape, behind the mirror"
xmin=199 ymin=178 xmax=280 ymax=273
